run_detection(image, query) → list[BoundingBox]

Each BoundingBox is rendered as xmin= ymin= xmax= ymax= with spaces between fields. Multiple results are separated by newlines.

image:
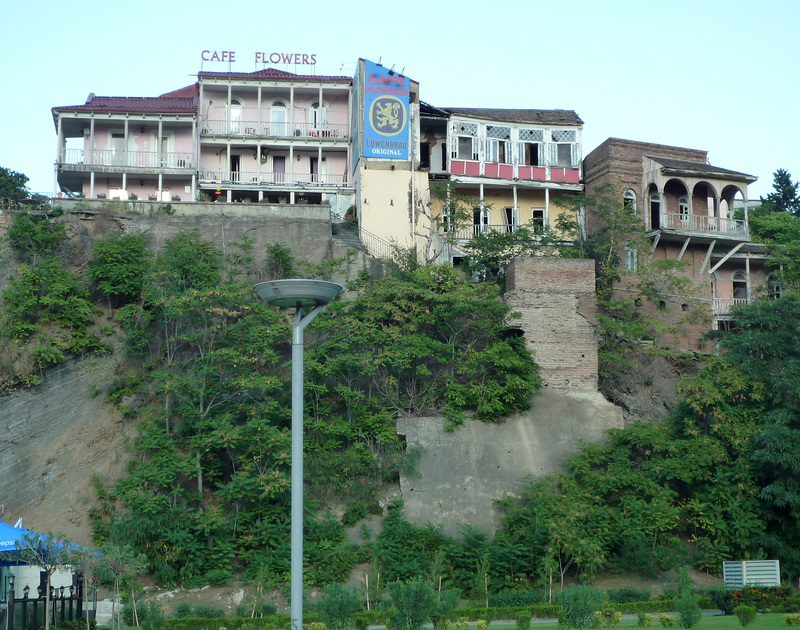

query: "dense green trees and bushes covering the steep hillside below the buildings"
xmin=0 ymin=180 xmax=800 ymax=598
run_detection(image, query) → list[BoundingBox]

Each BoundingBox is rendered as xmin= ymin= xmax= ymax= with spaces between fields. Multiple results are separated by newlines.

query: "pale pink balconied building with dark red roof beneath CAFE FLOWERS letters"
xmin=53 ymin=69 xmax=354 ymax=213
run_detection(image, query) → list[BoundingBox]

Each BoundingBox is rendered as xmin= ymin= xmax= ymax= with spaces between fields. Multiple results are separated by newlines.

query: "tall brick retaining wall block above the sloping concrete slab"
xmin=505 ymin=258 xmax=597 ymax=390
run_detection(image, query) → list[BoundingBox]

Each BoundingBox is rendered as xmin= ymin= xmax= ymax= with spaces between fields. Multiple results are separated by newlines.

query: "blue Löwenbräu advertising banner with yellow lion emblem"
xmin=363 ymin=59 xmax=409 ymax=160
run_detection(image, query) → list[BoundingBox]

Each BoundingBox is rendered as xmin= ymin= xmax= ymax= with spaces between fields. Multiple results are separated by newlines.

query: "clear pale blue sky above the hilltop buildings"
xmin=0 ymin=0 xmax=800 ymax=199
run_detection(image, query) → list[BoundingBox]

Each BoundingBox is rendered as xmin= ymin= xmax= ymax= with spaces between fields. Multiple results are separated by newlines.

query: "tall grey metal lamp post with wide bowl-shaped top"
xmin=253 ymin=280 xmax=342 ymax=630
